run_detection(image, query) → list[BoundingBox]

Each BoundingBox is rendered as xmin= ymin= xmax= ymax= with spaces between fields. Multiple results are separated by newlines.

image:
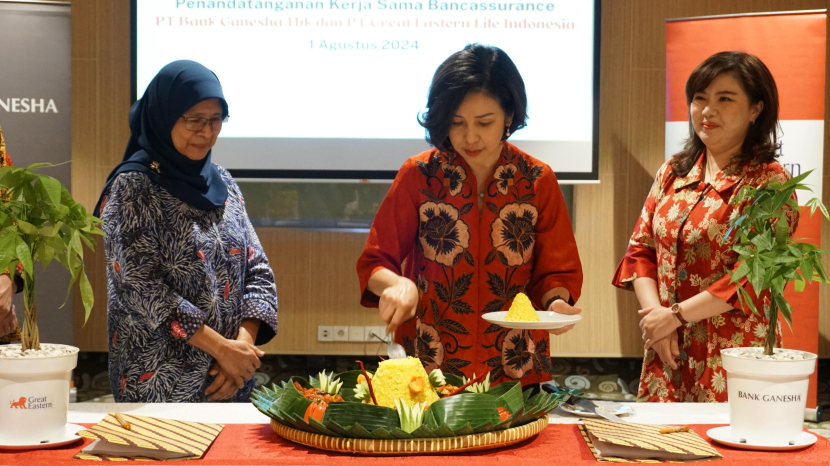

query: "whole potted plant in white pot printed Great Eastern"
xmin=0 ymin=163 xmax=104 ymax=446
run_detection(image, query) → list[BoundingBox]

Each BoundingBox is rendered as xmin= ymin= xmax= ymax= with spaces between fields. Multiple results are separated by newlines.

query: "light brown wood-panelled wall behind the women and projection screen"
xmin=72 ymin=0 xmax=830 ymax=357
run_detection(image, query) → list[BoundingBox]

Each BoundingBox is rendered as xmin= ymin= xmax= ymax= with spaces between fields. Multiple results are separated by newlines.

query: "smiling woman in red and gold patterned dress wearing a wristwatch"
xmin=613 ymin=52 xmax=797 ymax=402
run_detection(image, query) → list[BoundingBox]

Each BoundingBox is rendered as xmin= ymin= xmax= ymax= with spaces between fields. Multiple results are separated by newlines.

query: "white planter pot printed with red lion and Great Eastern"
xmin=0 ymin=346 xmax=78 ymax=445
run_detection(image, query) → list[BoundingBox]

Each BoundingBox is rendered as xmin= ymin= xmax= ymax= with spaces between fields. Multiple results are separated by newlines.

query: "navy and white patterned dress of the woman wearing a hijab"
xmin=101 ymin=167 xmax=277 ymax=402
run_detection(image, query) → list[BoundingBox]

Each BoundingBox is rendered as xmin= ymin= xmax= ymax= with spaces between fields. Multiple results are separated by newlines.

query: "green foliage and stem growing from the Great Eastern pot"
xmin=0 ymin=163 xmax=104 ymax=351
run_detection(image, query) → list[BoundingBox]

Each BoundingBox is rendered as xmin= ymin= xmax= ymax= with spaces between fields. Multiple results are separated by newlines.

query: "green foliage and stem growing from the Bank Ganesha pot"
xmin=723 ymin=170 xmax=830 ymax=355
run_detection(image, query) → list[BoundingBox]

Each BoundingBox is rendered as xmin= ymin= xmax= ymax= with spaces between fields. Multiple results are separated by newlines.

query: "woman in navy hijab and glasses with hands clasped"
xmin=95 ymin=60 xmax=277 ymax=402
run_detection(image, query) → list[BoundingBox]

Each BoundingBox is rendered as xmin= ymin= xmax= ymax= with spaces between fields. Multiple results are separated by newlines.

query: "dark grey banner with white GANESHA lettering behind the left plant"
xmin=0 ymin=0 xmax=72 ymax=343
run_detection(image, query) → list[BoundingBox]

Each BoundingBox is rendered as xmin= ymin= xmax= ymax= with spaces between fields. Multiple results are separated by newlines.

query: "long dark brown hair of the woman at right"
xmin=671 ymin=52 xmax=780 ymax=176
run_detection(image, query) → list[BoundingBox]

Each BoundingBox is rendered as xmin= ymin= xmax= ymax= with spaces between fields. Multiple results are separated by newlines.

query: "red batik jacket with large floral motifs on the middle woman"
xmin=357 ymin=143 xmax=582 ymax=384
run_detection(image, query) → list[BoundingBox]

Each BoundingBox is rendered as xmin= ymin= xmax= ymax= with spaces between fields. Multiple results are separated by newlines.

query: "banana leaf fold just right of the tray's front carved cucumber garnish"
xmin=424 ymin=393 xmax=501 ymax=431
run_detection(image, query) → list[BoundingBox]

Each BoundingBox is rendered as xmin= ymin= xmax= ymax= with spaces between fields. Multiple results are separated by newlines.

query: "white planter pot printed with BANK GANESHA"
xmin=721 ymin=348 xmax=817 ymax=446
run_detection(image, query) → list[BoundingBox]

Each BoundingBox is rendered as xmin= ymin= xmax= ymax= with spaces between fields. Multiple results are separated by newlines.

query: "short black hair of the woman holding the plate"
xmin=418 ymin=44 xmax=527 ymax=151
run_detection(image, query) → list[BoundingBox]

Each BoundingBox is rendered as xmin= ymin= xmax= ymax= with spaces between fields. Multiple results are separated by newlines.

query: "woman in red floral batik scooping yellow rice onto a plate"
xmin=357 ymin=44 xmax=582 ymax=384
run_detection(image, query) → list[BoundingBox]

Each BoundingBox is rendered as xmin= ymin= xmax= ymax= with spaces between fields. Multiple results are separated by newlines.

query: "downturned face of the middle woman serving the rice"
xmin=450 ymin=92 xmax=512 ymax=173
